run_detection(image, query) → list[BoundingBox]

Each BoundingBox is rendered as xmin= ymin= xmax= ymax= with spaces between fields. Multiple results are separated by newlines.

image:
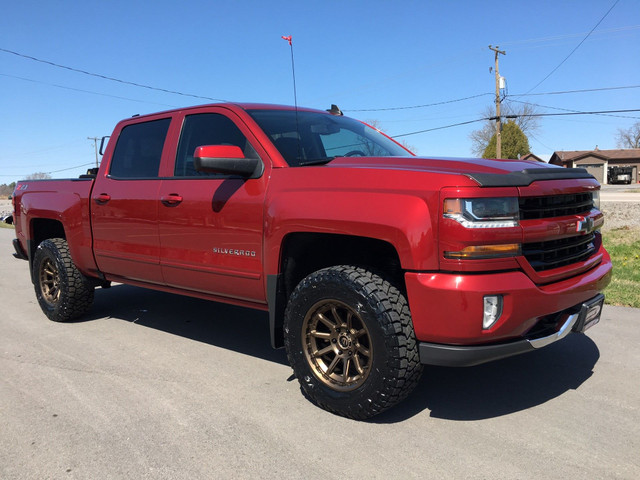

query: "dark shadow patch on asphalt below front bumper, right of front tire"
xmin=371 ymin=334 xmax=600 ymax=423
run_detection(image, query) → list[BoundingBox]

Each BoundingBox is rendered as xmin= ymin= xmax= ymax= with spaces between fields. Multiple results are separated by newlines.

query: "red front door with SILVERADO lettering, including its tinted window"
xmin=158 ymin=107 xmax=269 ymax=302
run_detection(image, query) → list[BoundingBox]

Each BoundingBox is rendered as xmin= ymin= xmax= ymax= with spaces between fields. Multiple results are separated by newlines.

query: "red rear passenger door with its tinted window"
xmin=91 ymin=116 xmax=171 ymax=284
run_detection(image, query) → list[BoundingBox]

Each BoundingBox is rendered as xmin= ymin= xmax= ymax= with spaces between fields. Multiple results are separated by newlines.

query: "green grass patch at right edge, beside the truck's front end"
xmin=602 ymin=227 xmax=640 ymax=308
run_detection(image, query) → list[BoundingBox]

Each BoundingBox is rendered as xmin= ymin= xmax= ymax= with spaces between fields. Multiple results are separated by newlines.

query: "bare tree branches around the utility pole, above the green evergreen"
xmin=469 ymin=103 xmax=540 ymax=157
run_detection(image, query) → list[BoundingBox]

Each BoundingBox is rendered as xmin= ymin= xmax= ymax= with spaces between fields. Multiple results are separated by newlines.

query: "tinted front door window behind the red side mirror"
xmin=174 ymin=113 xmax=258 ymax=177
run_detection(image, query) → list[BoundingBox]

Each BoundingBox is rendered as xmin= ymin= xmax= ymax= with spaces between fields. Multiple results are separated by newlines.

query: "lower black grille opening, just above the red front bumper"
xmin=522 ymin=233 xmax=596 ymax=272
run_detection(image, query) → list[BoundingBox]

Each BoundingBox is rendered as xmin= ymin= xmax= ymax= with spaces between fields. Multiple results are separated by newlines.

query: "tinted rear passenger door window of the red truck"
xmin=109 ymin=118 xmax=171 ymax=178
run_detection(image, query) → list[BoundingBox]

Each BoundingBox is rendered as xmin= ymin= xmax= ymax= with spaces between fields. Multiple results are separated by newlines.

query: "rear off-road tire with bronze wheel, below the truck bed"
xmin=33 ymin=238 xmax=94 ymax=322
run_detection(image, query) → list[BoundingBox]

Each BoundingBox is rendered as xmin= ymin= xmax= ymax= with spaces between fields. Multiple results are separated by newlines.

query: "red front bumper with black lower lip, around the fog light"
xmin=405 ymin=249 xmax=612 ymax=365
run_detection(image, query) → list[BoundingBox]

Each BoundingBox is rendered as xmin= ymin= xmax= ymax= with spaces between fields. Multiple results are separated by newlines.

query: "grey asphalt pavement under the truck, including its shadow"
xmin=0 ymin=229 xmax=640 ymax=480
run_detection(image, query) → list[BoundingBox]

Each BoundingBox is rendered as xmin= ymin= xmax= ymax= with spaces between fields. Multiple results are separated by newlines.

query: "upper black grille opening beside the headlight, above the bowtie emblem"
xmin=520 ymin=192 xmax=593 ymax=220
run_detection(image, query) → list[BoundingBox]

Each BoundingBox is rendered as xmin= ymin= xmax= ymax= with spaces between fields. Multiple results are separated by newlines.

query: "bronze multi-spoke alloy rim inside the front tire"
xmin=302 ymin=300 xmax=373 ymax=391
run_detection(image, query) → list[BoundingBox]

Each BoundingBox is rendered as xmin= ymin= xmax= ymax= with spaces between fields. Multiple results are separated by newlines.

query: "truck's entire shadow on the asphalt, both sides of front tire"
xmin=86 ymin=285 xmax=600 ymax=423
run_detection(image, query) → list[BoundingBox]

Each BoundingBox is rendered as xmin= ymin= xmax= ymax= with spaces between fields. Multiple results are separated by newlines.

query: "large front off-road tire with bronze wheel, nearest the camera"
xmin=284 ymin=266 xmax=422 ymax=420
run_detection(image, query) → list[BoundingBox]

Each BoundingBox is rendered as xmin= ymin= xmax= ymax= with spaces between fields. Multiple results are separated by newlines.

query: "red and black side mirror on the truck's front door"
xmin=193 ymin=145 xmax=263 ymax=178
